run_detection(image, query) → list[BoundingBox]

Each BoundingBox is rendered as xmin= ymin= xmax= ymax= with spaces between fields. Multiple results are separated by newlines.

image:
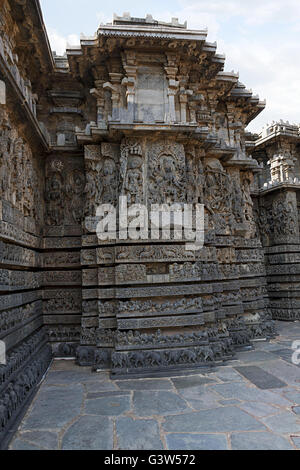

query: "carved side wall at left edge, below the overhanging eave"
xmin=0 ymin=100 xmax=51 ymax=448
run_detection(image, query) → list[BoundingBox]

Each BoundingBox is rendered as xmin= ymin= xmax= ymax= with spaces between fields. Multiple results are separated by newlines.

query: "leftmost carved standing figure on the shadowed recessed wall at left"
xmin=45 ymin=172 xmax=64 ymax=226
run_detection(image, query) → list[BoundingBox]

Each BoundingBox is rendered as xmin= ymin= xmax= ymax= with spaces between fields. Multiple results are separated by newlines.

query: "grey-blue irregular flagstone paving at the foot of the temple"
xmin=10 ymin=322 xmax=300 ymax=450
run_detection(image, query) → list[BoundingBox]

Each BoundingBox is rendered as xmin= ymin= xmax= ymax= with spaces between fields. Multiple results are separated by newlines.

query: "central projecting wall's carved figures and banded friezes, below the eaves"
xmin=77 ymin=137 xmax=274 ymax=375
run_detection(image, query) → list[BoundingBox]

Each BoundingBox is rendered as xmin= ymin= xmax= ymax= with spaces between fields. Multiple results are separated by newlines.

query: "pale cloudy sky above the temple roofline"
xmin=40 ymin=0 xmax=300 ymax=131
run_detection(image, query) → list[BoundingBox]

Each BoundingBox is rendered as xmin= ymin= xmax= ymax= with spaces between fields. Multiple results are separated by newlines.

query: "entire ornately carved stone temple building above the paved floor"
xmin=0 ymin=0 xmax=300 ymax=442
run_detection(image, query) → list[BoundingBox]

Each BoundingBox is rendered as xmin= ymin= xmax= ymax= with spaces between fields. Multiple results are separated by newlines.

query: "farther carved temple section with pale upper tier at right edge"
xmin=253 ymin=122 xmax=300 ymax=321
